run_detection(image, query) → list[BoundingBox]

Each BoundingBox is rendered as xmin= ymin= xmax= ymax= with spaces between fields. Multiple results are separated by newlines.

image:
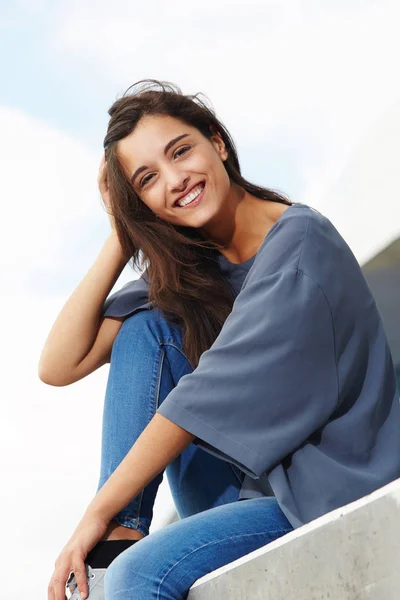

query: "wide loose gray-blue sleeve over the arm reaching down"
xmin=157 ymin=262 xmax=338 ymax=479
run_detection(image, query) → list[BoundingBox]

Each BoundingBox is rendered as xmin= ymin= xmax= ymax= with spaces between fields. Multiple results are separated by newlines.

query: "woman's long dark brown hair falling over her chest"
xmin=104 ymin=79 xmax=291 ymax=368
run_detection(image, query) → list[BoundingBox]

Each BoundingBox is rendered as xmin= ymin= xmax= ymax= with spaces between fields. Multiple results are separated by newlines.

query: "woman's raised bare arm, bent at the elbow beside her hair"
xmin=38 ymin=231 xmax=127 ymax=386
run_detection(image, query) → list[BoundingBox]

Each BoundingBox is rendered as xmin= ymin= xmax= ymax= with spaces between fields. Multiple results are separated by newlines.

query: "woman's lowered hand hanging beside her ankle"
xmin=48 ymin=514 xmax=108 ymax=600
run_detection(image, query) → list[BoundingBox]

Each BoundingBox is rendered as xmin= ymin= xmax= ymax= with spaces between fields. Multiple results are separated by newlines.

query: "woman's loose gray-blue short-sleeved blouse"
xmin=103 ymin=204 xmax=400 ymax=527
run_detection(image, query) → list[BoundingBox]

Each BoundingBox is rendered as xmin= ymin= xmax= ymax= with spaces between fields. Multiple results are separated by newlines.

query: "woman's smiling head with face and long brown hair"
xmin=104 ymin=80 xmax=291 ymax=367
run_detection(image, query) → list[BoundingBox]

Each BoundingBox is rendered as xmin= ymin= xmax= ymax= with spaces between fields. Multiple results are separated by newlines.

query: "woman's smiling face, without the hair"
xmin=118 ymin=115 xmax=230 ymax=228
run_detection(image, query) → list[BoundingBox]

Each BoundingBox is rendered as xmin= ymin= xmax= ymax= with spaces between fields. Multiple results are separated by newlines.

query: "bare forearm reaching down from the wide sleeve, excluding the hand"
xmin=86 ymin=413 xmax=196 ymax=521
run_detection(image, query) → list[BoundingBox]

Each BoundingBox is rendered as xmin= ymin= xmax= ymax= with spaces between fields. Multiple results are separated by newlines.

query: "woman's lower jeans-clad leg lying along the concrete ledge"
xmin=104 ymin=497 xmax=292 ymax=600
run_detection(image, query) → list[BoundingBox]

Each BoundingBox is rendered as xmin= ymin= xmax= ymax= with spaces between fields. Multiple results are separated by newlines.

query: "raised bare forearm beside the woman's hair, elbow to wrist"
xmin=39 ymin=234 xmax=127 ymax=373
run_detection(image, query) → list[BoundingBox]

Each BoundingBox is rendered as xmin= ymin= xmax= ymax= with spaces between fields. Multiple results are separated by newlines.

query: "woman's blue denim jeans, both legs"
xmin=95 ymin=309 xmax=292 ymax=600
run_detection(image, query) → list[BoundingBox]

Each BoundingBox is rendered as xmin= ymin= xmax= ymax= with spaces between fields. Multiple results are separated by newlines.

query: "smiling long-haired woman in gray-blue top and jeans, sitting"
xmin=40 ymin=80 xmax=400 ymax=600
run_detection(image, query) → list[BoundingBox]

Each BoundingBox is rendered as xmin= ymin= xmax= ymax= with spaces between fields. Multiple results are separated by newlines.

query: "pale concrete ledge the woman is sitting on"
xmin=188 ymin=479 xmax=400 ymax=600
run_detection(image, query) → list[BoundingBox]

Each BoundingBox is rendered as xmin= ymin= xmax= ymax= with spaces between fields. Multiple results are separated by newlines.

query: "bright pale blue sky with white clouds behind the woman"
xmin=0 ymin=0 xmax=400 ymax=600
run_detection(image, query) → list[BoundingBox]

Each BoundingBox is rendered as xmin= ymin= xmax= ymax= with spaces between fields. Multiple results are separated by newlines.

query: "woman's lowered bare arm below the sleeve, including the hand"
xmin=48 ymin=414 xmax=195 ymax=600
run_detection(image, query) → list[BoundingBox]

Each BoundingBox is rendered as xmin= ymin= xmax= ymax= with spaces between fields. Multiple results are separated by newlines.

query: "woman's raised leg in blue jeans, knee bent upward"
xmin=98 ymin=310 xmax=244 ymax=536
